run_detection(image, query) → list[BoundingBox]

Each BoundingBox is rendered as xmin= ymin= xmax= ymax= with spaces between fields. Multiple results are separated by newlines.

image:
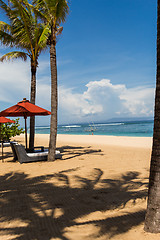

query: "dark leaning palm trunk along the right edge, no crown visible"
xmin=144 ymin=0 xmax=160 ymax=233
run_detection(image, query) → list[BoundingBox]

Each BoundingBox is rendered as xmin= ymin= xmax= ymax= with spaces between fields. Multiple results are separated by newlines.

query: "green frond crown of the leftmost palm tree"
xmin=0 ymin=0 xmax=48 ymax=60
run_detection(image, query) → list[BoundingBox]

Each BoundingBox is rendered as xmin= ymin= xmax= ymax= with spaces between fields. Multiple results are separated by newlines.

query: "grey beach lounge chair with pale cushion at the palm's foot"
xmin=13 ymin=144 xmax=62 ymax=163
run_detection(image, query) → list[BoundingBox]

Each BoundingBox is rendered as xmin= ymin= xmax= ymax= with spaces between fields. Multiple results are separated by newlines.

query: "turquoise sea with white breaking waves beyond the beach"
xmin=35 ymin=120 xmax=153 ymax=137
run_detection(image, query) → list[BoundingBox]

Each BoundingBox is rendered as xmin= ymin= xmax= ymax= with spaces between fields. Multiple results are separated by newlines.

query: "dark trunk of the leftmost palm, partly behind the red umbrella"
xmin=29 ymin=62 xmax=37 ymax=149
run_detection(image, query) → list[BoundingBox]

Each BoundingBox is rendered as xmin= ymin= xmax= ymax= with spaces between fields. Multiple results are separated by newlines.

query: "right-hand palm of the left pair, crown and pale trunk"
xmin=33 ymin=0 xmax=69 ymax=161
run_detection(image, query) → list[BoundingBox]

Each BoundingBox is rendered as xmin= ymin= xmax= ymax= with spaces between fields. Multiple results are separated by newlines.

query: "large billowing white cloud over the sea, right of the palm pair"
xmin=59 ymin=79 xmax=154 ymax=122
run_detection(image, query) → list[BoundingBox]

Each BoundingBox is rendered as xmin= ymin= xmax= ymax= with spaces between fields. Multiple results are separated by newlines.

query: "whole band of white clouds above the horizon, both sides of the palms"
xmin=0 ymin=61 xmax=154 ymax=124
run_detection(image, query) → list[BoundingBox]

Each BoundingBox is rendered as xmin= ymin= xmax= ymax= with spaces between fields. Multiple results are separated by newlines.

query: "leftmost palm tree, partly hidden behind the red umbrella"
xmin=0 ymin=0 xmax=49 ymax=149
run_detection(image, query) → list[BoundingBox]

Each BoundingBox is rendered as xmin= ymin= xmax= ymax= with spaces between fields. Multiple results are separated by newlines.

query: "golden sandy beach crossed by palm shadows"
xmin=0 ymin=134 xmax=160 ymax=240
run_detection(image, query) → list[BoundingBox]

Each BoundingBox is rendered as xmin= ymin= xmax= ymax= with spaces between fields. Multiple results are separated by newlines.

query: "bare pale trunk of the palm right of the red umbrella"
xmin=48 ymin=27 xmax=58 ymax=161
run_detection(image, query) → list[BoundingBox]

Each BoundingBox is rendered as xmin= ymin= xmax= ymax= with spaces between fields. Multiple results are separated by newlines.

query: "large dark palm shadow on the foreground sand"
xmin=0 ymin=168 xmax=147 ymax=240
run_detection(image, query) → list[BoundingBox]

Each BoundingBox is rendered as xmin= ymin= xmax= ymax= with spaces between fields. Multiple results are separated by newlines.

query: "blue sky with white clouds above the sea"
xmin=0 ymin=0 xmax=157 ymax=125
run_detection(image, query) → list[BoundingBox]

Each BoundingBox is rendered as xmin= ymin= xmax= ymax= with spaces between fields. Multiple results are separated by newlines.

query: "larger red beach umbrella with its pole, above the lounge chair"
xmin=0 ymin=98 xmax=51 ymax=148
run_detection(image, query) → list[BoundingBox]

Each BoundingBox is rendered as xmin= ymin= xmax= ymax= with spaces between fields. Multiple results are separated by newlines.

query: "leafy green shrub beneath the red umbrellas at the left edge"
xmin=1 ymin=118 xmax=24 ymax=141
